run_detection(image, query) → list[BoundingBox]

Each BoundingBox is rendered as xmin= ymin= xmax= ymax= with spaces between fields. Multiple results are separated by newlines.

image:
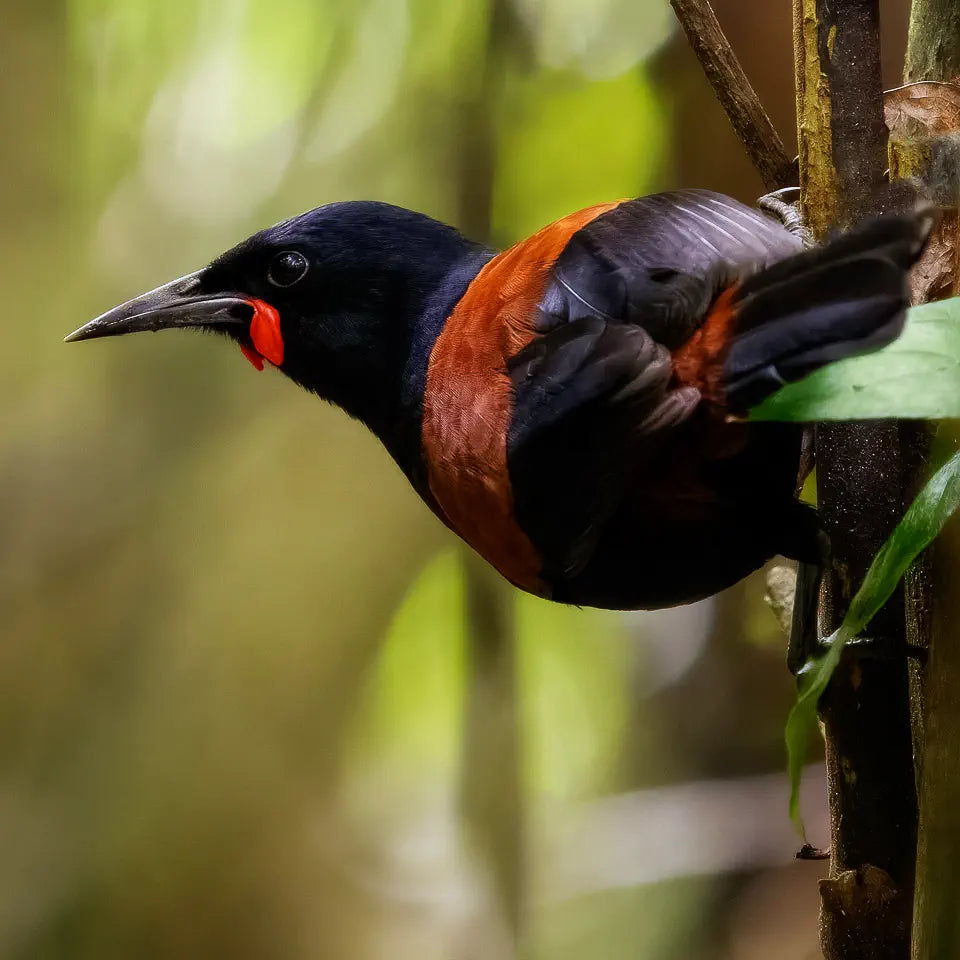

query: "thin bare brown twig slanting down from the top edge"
xmin=670 ymin=0 xmax=797 ymax=190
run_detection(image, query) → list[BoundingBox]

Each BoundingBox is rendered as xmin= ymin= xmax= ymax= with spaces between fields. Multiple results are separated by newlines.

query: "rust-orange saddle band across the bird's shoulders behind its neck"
xmin=422 ymin=201 xmax=622 ymax=594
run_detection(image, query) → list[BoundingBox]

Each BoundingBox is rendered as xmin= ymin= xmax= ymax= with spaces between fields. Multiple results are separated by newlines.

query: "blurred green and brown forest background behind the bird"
xmin=0 ymin=0 xmax=907 ymax=960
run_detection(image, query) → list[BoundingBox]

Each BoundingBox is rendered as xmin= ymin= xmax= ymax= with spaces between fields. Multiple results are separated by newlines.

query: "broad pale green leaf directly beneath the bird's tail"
xmin=750 ymin=297 xmax=960 ymax=421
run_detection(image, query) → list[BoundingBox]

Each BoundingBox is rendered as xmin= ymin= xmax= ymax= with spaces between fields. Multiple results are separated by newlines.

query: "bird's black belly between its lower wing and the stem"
xmin=551 ymin=418 xmax=810 ymax=610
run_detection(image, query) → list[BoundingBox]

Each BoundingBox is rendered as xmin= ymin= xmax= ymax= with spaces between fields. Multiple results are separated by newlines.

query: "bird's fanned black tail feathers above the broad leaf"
xmin=723 ymin=210 xmax=935 ymax=411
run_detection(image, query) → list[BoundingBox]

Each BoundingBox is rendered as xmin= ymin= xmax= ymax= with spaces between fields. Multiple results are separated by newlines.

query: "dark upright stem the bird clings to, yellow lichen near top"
xmin=795 ymin=0 xmax=916 ymax=960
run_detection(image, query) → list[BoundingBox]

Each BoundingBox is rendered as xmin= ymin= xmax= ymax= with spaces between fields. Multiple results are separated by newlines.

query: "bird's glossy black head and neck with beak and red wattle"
xmin=66 ymin=202 xmax=492 ymax=455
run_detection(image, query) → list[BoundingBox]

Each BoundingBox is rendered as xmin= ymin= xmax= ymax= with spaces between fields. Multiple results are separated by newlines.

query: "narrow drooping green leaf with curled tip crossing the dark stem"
xmin=785 ymin=453 xmax=960 ymax=834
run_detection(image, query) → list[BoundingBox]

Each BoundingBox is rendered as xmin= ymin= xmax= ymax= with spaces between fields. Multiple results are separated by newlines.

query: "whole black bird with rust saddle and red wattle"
xmin=66 ymin=189 xmax=932 ymax=624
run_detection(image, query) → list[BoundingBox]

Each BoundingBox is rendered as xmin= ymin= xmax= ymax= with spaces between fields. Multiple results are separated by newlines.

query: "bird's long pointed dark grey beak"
xmin=63 ymin=271 xmax=253 ymax=343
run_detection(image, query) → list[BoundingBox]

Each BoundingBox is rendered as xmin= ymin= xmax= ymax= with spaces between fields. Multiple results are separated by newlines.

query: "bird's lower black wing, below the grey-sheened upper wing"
xmin=507 ymin=317 xmax=700 ymax=583
